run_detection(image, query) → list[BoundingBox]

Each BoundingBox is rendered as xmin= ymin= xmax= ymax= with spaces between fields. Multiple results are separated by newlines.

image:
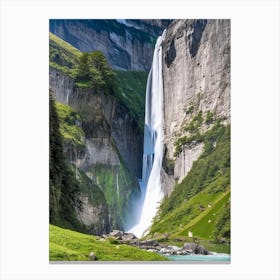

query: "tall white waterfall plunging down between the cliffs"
xmin=129 ymin=31 xmax=165 ymax=237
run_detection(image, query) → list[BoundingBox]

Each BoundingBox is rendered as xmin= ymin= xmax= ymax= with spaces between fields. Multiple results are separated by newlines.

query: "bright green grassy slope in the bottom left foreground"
xmin=49 ymin=225 xmax=167 ymax=261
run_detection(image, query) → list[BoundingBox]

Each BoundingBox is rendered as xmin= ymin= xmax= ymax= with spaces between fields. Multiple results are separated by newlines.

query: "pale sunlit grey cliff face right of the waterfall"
xmin=162 ymin=20 xmax=230 ymax=194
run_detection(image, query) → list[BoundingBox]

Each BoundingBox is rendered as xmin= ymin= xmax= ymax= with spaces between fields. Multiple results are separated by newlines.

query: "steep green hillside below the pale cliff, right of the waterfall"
xmin=149 ymin=120 xmax=230 ymax=252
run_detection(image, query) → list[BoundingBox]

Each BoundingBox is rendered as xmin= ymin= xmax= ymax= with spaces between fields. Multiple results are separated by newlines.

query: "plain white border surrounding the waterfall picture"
xmin=0 ymin=0 xmax=280 ymax=280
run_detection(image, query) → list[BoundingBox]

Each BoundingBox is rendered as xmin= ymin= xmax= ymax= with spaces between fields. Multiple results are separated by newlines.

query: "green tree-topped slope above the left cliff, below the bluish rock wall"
xmin=49 ymin=32 xmax=148 ymax=131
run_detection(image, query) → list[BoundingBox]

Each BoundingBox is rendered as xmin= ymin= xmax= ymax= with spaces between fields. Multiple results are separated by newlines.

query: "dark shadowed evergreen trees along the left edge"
xmin=49 ymin=91 xmax=81 ymax=229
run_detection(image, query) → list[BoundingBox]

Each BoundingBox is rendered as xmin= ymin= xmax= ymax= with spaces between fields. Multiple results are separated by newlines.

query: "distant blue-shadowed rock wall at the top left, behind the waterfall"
xmin=50 ymin=20 xmax=169 ymax=71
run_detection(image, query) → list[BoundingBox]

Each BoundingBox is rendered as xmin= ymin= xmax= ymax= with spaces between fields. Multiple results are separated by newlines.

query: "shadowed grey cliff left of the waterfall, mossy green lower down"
xmin=49 ymin=68 xmax=143 ymax=233
